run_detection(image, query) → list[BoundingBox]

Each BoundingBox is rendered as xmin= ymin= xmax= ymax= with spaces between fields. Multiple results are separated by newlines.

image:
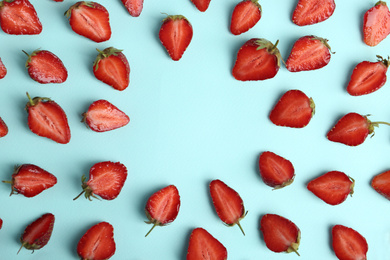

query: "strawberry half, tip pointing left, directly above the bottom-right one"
xmin=307 ymin=171 xmax=355 ymax=205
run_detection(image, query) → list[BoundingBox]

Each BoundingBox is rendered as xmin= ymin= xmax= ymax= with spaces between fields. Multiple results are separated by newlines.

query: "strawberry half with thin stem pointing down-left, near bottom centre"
xmin=145 ymin=185 xmax=180 ymax=237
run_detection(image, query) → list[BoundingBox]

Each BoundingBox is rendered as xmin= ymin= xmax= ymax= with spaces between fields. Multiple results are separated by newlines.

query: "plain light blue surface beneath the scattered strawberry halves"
xmin=0 ymin=0 xmax=390 ymax=260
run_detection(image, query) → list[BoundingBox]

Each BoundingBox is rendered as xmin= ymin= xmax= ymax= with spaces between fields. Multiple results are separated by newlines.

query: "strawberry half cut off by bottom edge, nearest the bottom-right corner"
xmin=332 ymin=225 xmax=368 ymax=260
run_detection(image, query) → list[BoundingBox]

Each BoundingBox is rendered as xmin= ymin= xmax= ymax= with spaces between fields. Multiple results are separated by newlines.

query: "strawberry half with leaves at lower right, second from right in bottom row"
xmin=260 ymin=214 xmax=301 ymax=255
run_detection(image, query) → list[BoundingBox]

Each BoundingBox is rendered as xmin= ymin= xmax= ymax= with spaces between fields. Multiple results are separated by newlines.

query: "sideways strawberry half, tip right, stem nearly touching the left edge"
xmin=3 ymin=164 xmax=57 ymax=198
